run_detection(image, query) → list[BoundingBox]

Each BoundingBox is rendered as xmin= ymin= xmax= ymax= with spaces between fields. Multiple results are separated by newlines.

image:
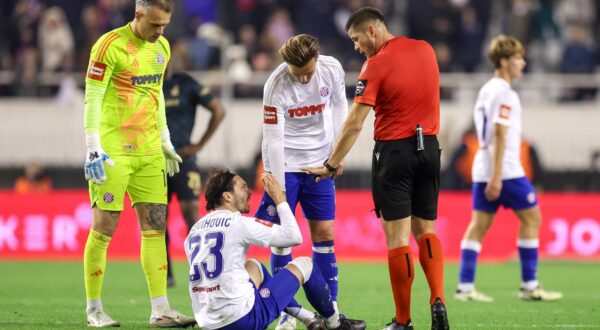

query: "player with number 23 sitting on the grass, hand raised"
xmin=185 ymin=170 xmax=366 ymax=329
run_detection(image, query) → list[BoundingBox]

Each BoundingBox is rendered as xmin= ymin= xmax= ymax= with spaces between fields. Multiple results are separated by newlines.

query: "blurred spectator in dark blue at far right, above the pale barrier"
xmin=560 ymin=25 xmax=597 ymax=101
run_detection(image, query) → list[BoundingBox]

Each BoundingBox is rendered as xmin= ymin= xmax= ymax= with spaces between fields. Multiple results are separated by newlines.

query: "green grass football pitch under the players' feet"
xmin=0 ymin=261 xmax=600 ymax=329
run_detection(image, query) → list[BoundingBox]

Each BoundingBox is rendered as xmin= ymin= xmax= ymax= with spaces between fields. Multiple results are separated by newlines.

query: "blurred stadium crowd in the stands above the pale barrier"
xmin=0 ymin=0 xmax=600 ymax=100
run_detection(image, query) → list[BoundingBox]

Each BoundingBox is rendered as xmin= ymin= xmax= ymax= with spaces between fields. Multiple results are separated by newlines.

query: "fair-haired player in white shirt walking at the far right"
xmin=455 ymin=35 xmax=562 ymax=302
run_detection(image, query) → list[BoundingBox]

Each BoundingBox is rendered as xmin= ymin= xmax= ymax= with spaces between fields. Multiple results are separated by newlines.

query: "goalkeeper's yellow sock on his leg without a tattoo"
xmin=83 ymin=229 xmax=111 ymax=300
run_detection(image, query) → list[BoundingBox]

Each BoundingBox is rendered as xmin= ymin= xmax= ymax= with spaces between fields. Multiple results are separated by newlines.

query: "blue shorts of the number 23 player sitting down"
xmin=221 ymin=268 xmax=300 ymax=330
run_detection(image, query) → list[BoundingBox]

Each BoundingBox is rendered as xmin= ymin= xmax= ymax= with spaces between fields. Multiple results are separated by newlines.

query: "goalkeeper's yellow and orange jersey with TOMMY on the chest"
xmin=85 ymin=24 xmax=171 ymax=156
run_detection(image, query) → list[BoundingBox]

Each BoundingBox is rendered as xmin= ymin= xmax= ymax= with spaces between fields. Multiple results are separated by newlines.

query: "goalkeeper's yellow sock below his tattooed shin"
xmin=141 ymin=230 xmax=167 ymax=298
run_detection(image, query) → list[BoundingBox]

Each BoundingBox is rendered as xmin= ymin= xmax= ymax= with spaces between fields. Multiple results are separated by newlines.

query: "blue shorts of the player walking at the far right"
xmin=473 ymin=177 xmax=538 ymax=212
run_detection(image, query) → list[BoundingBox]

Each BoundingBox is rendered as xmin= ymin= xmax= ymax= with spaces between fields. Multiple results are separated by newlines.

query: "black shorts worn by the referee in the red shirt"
xmin=371 ymin=136 xmax=441 ymax=220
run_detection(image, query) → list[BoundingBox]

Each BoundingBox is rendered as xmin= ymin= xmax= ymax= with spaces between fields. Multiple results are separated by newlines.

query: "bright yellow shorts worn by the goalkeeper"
xmin=88 ymin=153 xmax=167 ymax=211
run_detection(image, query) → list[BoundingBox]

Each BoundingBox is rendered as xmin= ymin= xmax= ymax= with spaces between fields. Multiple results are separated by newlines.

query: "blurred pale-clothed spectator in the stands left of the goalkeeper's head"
xmin=38 ymin=7 xmax=75 ymax=71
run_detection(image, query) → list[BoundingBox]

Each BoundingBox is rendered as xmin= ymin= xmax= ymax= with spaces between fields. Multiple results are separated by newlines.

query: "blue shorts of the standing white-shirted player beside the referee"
xmin=255 ymin=172 xmax=335 ymax=223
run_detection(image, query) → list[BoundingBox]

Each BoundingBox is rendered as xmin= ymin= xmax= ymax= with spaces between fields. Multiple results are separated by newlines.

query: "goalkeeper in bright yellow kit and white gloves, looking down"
xmin=83 ymin=0 xmax=195 ymax=327
